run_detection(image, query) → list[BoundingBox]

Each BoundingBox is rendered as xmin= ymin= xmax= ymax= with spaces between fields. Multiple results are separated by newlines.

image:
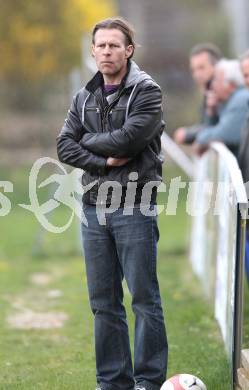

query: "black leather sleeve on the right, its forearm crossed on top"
xmin=81 ymin=84 xmax=164 ymax=158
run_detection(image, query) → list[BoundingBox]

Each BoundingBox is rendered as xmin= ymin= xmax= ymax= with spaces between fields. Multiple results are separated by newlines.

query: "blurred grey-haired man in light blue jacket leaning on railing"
xmin=194 ymin=59 xmax=249 ymax=156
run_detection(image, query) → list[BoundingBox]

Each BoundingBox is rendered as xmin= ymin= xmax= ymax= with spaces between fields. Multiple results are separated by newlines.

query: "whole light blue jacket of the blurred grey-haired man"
xmin=196 ymin=87 xmax=249 ymax=155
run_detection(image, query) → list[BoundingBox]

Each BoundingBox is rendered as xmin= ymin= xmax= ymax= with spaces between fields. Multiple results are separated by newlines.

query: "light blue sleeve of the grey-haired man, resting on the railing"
xmin=196 ymin=96 xmax=247 ymax=146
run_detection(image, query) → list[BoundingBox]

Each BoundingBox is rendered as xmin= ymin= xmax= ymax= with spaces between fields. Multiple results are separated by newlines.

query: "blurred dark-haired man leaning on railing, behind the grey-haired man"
xmin=174 ymin=43 xmax=221 ymax=144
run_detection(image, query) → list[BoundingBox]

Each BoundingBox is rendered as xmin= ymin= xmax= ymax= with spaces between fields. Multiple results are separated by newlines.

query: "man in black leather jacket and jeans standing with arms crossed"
xmin=57 ymin=18 xmax=168 ymax=390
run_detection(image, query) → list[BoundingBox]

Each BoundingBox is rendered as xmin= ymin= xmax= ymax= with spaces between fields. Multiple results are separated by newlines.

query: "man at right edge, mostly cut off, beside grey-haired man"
xmin=238 ymin=50 xmax=249 ymax=283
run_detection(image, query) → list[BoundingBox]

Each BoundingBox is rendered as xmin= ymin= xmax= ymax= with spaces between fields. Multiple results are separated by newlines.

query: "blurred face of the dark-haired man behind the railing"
xmin=190 ymin=52 xmax=214 ymax=89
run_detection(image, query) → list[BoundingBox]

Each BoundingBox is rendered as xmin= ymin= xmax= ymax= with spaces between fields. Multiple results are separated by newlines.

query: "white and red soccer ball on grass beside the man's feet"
xmin=160 ymin=374 xmax=207 ymax=390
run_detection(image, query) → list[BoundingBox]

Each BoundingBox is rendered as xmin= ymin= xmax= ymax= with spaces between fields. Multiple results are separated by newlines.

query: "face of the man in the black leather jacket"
xmin=92 ymin=29 xmax=133 ymax=81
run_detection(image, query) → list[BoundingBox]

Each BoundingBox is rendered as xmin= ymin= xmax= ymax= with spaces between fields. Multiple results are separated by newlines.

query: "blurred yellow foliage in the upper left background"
xmin=0 ymin=0 xmax=115 ymax=83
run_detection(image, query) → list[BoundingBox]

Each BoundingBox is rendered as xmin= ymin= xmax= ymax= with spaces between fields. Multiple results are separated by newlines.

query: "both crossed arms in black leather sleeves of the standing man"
xmin=57 ymin=84 xmax=164 ymax=175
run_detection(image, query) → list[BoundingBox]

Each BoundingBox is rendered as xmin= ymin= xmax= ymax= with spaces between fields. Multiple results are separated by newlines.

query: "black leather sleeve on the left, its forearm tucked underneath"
xmin=56 ymin=95 xmax=106 ymax=175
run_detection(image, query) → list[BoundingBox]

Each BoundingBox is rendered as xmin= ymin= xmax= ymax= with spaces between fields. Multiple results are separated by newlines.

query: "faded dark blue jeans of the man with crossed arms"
xmin=81 ymin=204 xmax=168 ymax=390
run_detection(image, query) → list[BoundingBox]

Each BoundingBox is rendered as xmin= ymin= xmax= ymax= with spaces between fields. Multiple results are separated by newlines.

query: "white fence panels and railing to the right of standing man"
xmin=190 ymin=142 xmax=247 ymax=385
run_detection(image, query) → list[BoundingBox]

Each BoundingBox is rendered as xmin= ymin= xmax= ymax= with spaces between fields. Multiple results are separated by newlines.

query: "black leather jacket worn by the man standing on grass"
xmin=57 ymin=61 xmax=165 ymax=204
